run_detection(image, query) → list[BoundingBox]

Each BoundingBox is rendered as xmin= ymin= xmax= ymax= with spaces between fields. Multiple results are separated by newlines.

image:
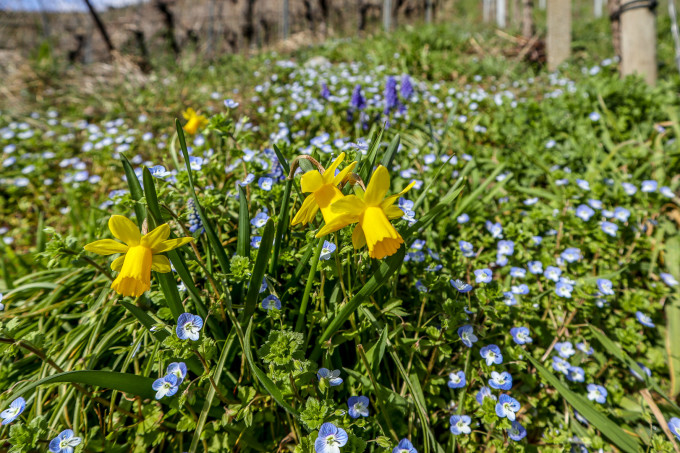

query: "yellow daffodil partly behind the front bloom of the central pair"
xmin=291 ymin=153 xmax=357 ymax=226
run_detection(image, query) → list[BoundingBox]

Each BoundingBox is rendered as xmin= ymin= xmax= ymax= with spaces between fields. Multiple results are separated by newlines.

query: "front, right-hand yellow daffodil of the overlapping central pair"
xmin=316 ymin=165 xmax=415 ymax=259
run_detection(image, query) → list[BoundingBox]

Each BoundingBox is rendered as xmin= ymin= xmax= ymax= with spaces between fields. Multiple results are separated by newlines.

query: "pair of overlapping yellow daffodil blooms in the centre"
xmin=291 ymin=158 xmax=415 ymax=259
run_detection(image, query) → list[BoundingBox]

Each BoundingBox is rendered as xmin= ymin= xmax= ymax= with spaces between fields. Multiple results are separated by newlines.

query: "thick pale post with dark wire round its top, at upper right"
xmin=621 ymin=1 xmax=657 ymax=85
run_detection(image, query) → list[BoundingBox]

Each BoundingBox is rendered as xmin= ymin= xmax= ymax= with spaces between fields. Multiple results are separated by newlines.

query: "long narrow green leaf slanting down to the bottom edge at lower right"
xmin=527 ymin=355 xmax=640 ymax=453
